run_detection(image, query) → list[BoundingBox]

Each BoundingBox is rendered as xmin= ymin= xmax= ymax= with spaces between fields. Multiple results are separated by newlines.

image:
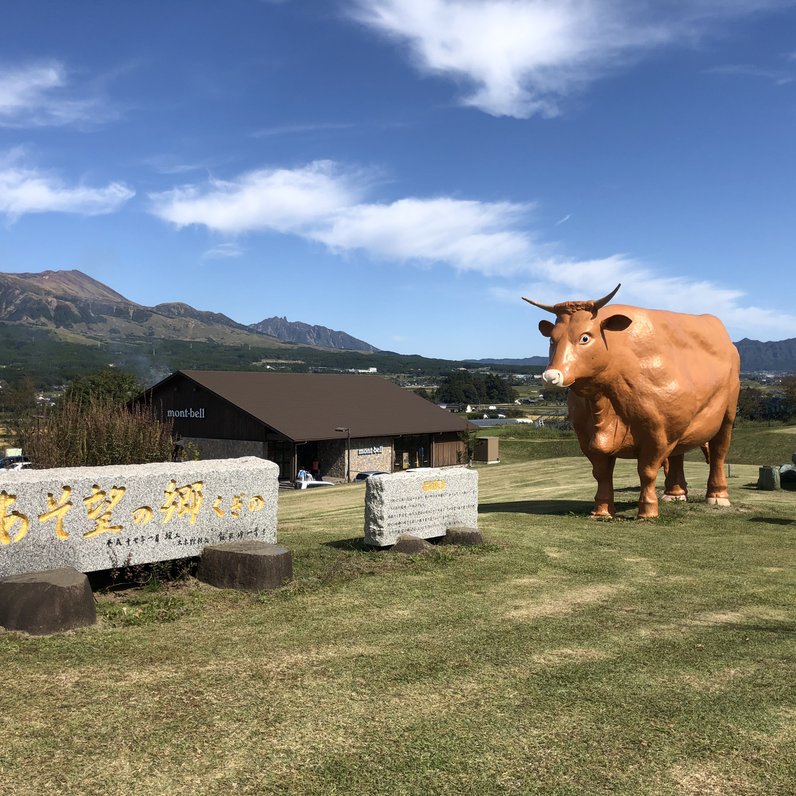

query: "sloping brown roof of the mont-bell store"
xmin=158 ymin=370 xmax=468 ymax=441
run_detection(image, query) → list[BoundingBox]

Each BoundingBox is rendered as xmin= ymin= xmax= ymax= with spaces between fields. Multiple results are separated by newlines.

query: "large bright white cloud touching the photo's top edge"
xmin=349 ymin=0 xmax=788 ymax=118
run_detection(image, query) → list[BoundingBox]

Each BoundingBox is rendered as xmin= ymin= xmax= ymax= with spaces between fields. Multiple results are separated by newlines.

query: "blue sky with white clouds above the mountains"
xmin=0 ymin=0 xmax=796 ymax=358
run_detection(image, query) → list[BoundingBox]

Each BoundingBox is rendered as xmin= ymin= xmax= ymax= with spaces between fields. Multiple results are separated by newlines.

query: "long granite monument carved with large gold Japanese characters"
xmin=0 ymin=456 xmax=279 ymax=578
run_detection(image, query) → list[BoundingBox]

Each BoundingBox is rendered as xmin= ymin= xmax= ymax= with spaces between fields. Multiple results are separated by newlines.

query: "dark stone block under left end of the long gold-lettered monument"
xmin=0 ymin=567 xmax=97 ymax=636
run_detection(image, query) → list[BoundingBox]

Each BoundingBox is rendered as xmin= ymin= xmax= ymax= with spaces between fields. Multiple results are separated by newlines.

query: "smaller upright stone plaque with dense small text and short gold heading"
xmin=365 ymin=467 xmax=478 ymax=547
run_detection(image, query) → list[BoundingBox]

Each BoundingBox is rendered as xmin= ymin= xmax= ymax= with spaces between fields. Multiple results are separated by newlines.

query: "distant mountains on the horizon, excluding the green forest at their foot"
xmin=0 ymin=270 xmax=796 ymax=373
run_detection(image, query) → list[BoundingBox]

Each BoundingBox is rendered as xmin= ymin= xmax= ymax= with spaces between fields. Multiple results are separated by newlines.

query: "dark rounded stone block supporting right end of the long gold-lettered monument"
xmin=197 ymin=542 xmax=293 ymax=591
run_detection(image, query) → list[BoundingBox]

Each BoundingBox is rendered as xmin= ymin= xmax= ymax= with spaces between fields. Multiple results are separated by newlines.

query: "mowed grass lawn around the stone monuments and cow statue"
xmin=0 ymin=458 xmax=796 ymax=796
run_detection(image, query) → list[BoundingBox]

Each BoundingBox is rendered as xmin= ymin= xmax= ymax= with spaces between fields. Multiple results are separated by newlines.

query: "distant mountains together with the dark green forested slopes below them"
xmin=0 ymin=270 xmax=796 ymax=378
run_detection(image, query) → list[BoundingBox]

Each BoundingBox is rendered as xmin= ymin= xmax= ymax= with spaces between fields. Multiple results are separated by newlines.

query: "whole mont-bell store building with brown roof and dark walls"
xmin=142 ymin=370 xmax=469 ymax=480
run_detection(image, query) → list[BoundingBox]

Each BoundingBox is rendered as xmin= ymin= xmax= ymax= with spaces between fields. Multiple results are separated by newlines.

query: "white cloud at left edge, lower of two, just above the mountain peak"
xmin=0 ymin=150 xmax=135 ymax=221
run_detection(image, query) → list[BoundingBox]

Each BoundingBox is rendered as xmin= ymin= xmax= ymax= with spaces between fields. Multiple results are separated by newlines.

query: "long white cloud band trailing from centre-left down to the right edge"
xmin=151 ymin=161 xmax=796 ymax=334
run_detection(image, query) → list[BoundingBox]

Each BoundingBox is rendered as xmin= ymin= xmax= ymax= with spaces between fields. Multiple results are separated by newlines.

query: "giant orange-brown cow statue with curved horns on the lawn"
xmin=523 ymin=285 xmax=740 ymax=519
